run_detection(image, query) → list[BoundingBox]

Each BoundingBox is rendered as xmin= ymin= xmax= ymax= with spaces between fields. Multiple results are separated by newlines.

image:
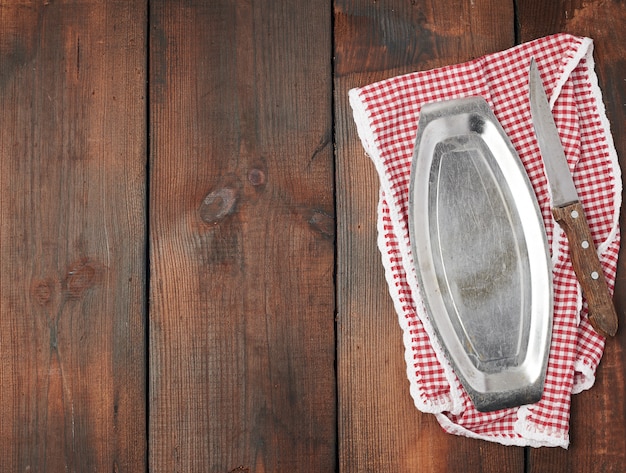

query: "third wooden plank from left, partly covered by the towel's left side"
xmin=334 ymin=0 xmax=524 ymax=472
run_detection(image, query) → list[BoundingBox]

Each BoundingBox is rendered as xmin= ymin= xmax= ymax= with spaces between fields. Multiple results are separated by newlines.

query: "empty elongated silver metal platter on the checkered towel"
xmin=409 ymin=97 xmax=553 ymax=412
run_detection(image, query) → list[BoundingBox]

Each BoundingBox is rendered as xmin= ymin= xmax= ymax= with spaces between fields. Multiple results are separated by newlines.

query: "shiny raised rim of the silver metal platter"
xmin=408 ymin=96 xmax=553 ymax=411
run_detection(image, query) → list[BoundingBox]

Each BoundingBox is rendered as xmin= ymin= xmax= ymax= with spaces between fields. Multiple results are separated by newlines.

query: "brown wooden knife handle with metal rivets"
xmin=552 ymin=202 xmax=617 ymax=337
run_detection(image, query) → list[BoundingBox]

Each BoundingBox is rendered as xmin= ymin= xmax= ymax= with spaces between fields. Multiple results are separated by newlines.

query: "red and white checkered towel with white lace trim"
xmin=350 ymin=34 xmax=621 ymax=448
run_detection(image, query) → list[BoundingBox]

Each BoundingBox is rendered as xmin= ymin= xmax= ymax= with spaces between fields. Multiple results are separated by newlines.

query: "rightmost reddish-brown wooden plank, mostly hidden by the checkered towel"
xmin=517 ymin=0 xmax=626 ymax=473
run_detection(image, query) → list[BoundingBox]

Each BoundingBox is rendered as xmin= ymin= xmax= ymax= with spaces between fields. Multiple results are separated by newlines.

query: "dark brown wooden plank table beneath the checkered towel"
xmin=0 ymin=0 xmax=626 ymax=473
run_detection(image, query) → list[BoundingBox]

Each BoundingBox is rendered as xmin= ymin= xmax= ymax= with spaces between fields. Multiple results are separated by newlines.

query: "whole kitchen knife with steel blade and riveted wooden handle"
xmin=528 ymin=58 xmax=618 ymax=337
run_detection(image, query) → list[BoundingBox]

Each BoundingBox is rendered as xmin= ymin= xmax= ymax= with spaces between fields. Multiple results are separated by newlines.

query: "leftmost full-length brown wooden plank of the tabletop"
xmin=0 ymin=0 xmax=147 ymax=472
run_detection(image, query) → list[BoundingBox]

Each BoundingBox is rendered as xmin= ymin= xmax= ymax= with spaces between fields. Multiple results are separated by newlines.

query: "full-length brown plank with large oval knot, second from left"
xmin=149 ymin=0 xmax=336 ymax=472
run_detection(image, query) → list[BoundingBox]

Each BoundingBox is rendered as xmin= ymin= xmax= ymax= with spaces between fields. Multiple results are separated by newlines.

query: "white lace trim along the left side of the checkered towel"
xmin=348 ymin=89 xmax=463 ymax=413
